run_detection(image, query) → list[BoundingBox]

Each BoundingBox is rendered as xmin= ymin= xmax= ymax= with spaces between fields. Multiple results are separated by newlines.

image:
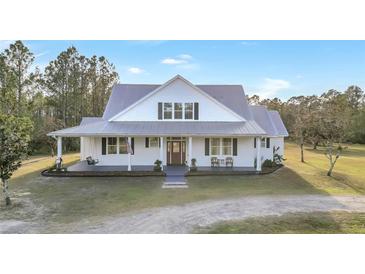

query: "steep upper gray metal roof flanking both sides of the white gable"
xmin=103 ymin=84 xmax=252 ymax=120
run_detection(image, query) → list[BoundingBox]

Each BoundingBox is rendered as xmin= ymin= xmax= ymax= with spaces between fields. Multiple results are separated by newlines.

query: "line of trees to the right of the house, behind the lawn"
xmin=247 ymin=85 xmax=365 ymax=175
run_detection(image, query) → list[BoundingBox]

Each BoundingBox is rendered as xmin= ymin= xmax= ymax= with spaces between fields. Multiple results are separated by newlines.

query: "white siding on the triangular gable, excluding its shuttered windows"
xmin=111 ymin=79 xmax=240 ymax=121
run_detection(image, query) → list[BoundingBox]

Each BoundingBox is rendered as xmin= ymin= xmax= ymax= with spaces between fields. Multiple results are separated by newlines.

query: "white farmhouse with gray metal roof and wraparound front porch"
xmin=48 ymin=75 xmax=288 ymax=171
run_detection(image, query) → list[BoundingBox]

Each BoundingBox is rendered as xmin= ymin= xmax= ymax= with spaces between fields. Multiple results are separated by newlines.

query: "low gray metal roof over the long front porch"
xmin=48 ymin=120 xmax=265 ymax=137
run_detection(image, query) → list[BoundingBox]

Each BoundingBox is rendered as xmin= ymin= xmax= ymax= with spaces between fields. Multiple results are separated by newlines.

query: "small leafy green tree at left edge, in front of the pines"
xmin=0 ymin=114 xmax=32 ymax=205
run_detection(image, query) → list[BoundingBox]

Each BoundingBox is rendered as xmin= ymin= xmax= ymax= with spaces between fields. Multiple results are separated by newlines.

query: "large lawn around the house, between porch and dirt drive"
xmin=0 ymin=144 xmax=365 ymax=232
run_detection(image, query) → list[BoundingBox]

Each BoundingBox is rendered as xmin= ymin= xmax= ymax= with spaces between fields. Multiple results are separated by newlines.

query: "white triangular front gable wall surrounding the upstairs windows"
xmin=109 ymin=76 xmax=245 ymax=122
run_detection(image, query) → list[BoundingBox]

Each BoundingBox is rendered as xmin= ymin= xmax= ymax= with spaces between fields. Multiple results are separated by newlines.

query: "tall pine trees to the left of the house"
xmin=0 ymin=41 xmax=119 ymax=154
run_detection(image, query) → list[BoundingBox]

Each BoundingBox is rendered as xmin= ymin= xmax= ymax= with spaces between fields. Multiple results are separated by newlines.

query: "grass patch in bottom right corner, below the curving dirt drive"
xmin=195 ymin=212 xmax=365 ymax=234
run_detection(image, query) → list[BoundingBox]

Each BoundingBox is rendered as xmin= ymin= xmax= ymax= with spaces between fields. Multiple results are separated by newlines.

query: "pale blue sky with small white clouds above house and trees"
xmin=0 ymin=40 xmax=365 ymax=100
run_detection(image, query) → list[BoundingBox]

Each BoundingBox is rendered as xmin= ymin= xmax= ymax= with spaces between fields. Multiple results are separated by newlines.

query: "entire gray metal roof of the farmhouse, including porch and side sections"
xmin=48 ymin=76 xmax=288 ymax=137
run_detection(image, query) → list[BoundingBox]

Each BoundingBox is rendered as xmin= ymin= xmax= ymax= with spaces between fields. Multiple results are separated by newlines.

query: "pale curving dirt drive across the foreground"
xmin=80 ymin=195 xmax=365 ymax=233
